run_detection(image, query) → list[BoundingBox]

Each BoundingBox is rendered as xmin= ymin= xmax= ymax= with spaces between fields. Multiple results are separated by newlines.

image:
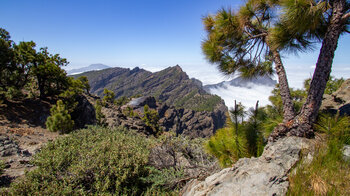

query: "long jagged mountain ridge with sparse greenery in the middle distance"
xmin=76 ymin=66 xmax=224 ymax=111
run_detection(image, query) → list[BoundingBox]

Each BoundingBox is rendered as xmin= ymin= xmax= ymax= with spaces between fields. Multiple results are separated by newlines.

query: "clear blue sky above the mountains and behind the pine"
xmin=0 ymin=0 xmax=350 ymax=87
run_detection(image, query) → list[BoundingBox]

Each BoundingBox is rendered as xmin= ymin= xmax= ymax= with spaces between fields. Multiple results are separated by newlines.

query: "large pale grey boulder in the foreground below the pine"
xmin=182 ymin=137 xmax=312 ymax=196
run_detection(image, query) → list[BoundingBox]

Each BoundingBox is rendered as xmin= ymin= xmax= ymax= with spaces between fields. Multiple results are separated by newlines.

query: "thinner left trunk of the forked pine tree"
xmin=272 ymin=51 xmax=296 ymax=123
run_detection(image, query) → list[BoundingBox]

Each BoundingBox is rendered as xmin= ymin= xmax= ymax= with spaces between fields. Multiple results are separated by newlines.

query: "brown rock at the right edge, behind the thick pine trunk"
xmin=320 ymin=79 xmax=350 ymax=115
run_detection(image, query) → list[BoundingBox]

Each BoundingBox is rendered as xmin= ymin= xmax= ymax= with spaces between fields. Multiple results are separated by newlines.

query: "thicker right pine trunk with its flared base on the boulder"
xmin=269 ymin=0 xmax=346 ymax=141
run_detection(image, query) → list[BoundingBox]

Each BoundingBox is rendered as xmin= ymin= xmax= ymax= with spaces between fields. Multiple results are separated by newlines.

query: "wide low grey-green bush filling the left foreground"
xmin=0 ymin=127 xmax=183 ymax=195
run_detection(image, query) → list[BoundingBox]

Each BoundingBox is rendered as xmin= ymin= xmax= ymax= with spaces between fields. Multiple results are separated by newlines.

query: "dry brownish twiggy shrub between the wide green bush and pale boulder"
xmin=148 ymin=136 xmax=220 ymax=186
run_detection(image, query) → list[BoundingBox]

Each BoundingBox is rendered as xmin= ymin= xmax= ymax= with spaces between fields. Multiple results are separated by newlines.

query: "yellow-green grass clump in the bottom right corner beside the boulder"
xmin=288 ymin=141 xmax=350 ymax=195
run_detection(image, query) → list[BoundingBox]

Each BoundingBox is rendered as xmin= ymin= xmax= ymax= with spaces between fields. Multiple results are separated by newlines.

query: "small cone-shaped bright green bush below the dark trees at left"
xmin=46 ymin=100 xmax=74 ymax=134
